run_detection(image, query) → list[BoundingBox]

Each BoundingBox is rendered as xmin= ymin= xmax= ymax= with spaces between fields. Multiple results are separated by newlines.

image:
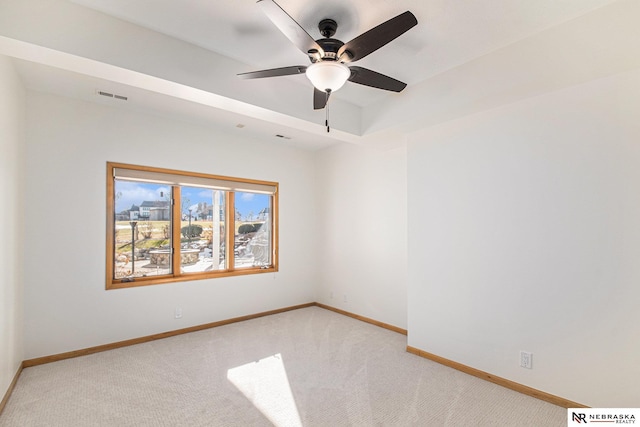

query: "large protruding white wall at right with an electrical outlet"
xmin=408 ymin=67 xmax=640 ymax=407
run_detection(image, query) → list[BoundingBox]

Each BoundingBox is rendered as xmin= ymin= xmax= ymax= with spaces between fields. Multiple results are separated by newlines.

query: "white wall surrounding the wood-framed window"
xmin=24 ymin=92 xmax=316 ymax=359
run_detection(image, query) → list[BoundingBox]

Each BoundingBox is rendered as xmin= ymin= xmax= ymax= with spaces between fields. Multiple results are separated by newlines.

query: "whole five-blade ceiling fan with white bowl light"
xmin=238 ymin=0 xmax=418 ymax=112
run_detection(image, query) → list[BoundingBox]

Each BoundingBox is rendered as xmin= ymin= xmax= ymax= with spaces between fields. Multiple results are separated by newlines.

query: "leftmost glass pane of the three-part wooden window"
xmin=113 ymin=180 xmax=171 ymax=279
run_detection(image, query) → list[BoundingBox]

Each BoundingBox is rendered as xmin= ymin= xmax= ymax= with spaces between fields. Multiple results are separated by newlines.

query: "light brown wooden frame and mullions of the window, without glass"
xmin=106 ymin=162 xmax=278 ymax=290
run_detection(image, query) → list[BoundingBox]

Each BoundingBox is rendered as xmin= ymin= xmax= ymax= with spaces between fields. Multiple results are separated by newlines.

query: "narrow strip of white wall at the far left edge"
xmin=0 ymin=55 xmax=25 ymax=400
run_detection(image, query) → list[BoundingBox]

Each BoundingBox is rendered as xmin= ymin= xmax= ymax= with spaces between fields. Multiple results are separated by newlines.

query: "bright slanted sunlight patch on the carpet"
xmin=227 ymin=353 xmax=302 ymax=427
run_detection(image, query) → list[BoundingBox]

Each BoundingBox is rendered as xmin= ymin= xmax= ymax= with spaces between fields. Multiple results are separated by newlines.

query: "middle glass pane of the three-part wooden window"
xmin=180 ymin=186 xmax=226 ymax=273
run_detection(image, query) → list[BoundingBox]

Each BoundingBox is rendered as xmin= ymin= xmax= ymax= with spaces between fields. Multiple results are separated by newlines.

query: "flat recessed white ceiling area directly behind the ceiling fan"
xmin=73 ymin=0 xmax=613 ymax=106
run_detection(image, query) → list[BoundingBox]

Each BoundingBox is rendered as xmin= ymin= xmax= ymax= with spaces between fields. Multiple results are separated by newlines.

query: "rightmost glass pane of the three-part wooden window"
xmin=234 ymin=192 xmax=272 ymax=268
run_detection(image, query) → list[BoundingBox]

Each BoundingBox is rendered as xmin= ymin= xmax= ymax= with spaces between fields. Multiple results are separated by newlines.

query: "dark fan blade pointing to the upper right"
xmin=338 ymin=11 xmax=418 ymax=62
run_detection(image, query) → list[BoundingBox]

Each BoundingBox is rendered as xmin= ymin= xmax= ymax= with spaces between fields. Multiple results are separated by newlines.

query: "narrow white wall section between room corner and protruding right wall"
xmin=316 ymin=144 xmax=407 ymax=328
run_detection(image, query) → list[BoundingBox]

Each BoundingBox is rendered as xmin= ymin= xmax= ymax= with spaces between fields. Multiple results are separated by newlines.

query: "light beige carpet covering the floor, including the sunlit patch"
xmin=0 ymin=307 xmax=566 ymax=427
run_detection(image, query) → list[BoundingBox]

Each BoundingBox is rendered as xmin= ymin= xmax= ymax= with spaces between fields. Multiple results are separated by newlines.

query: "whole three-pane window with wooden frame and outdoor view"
xmin=107 ymin=163 xmax=278 ymax=289
